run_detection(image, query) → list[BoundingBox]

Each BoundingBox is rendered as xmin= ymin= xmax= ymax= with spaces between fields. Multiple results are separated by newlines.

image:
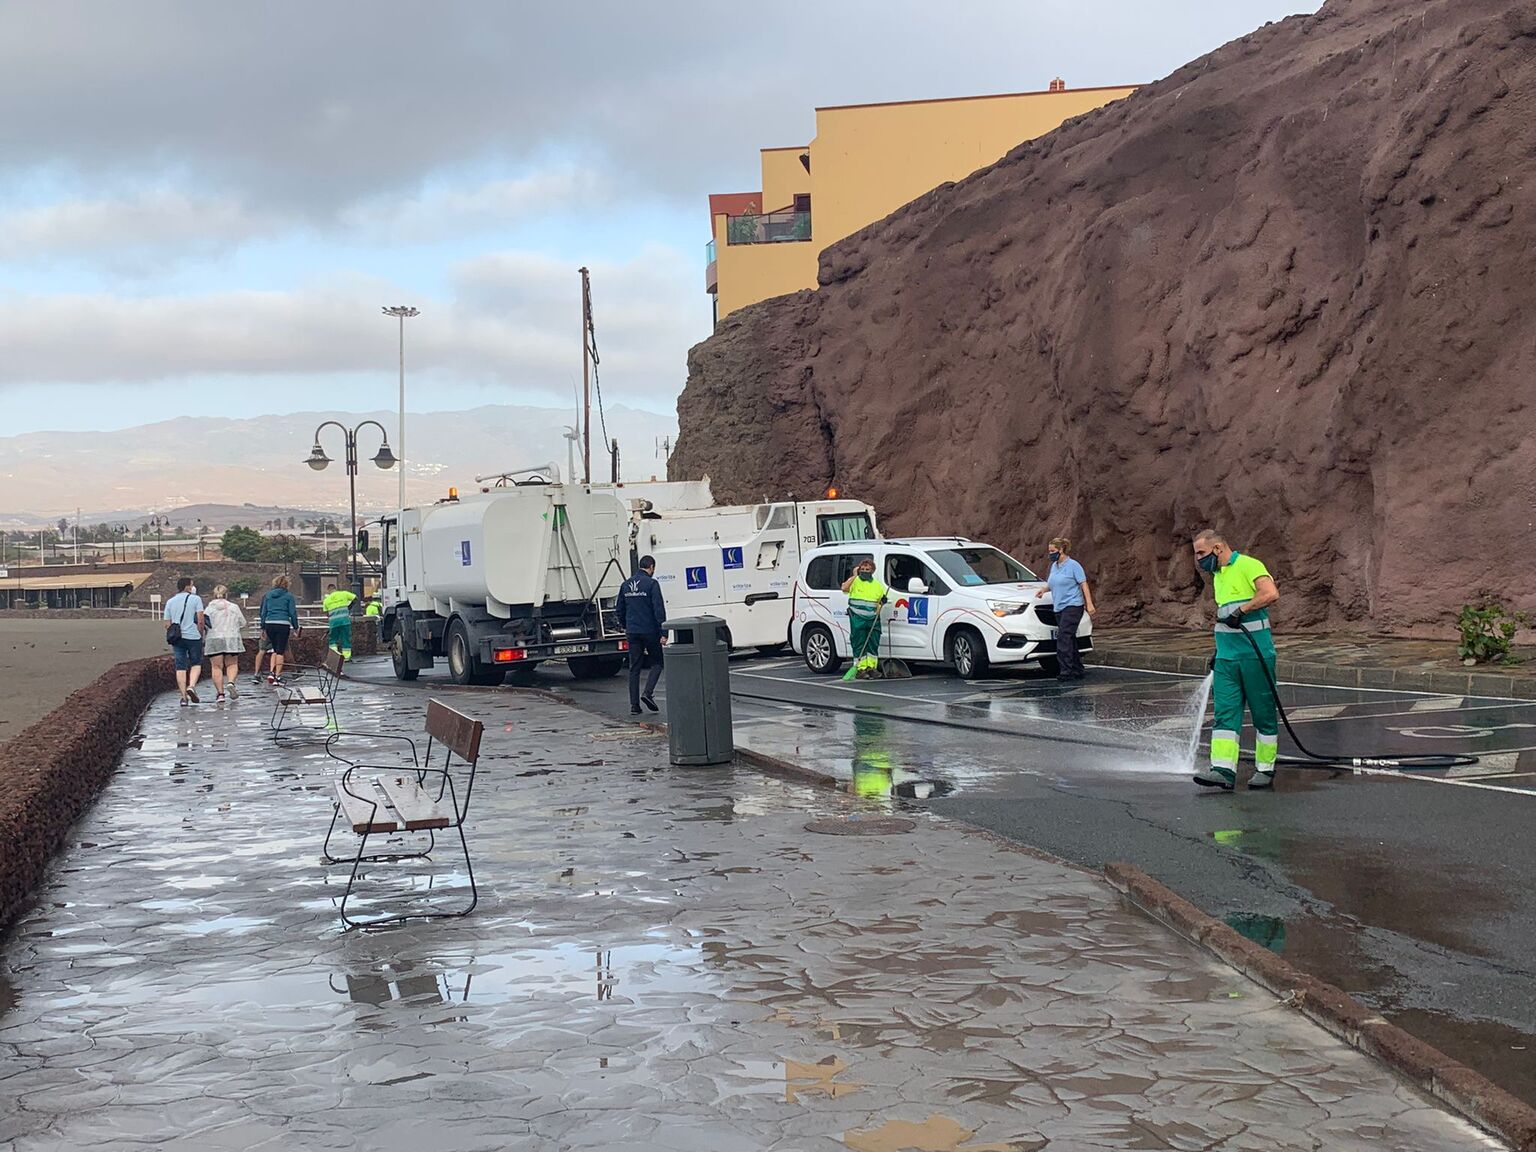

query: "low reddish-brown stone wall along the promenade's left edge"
xmin=0 ymin=656 xmax=175 ymax=929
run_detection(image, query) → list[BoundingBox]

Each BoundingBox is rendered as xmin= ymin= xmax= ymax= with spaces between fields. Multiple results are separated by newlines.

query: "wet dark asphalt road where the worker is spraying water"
xmin=348 ymin=659 xmax=1536 ymax=1100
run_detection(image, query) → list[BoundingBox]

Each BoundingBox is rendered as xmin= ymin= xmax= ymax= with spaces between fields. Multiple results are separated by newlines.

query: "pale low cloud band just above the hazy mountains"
xmin=0 ymin=246 xmax=708 ymax=407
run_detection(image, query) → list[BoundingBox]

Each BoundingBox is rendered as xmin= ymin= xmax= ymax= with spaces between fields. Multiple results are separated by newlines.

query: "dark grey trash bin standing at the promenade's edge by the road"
xmin=662 ymin=616 xmax=736 ymax=765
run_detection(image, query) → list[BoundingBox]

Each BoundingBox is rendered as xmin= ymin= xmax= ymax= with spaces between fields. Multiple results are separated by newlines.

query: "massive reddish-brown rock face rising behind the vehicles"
xmin=671 ymin=0 xmax=1536 ymax=630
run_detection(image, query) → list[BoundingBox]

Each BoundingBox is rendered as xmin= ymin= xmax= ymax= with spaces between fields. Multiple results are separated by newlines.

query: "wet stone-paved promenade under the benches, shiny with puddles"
xmin=0 ymin=684 xmax=1496 ymax=1152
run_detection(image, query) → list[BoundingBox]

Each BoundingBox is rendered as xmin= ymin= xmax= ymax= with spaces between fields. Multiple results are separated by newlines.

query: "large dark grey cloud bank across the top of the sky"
xmin=0 ymin=0 xmax=1316 ymax=220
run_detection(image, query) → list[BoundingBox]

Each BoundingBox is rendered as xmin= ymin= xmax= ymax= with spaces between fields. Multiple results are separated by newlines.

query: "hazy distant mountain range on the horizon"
xmin=0 ymin=404 xmax=677 ymax=528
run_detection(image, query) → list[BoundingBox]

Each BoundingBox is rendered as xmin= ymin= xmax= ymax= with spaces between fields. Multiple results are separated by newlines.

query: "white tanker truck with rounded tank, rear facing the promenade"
xmin=379 ymin=476 xmax=630 ymax=685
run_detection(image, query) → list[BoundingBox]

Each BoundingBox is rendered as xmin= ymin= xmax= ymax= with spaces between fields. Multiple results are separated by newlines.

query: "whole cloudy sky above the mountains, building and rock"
xmin=0 ymin=0 xmax=1316 ymax=435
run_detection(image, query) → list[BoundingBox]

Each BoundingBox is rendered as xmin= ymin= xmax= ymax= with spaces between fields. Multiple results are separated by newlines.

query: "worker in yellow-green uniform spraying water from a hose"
xmin=1195 ymin=528 xmax=1279 ymax=793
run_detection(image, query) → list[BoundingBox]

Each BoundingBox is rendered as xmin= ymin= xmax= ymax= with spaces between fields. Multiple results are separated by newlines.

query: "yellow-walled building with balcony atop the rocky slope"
xmin=705 ymin=80 xmax=1135 ymax=321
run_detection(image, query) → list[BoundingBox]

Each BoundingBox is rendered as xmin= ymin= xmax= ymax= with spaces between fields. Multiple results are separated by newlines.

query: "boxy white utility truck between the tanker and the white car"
xmin=630 ymin=499 xmax=877 ymax=653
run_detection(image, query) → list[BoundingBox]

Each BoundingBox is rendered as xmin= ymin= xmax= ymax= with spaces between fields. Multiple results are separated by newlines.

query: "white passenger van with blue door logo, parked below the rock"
xmin=790 ymin=536 xmax=1094 ymax=680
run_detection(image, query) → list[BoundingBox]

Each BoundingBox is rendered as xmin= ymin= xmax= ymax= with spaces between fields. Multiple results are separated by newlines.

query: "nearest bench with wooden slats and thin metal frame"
xmin=323 ymin=700 xmax=485 ymax=928
